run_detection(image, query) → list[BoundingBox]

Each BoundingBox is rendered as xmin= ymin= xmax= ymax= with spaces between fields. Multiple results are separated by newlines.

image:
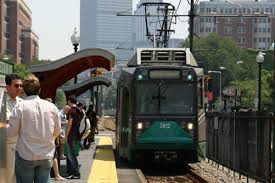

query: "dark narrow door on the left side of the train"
xmin=120 ymin=88 xmax=130 ymax=157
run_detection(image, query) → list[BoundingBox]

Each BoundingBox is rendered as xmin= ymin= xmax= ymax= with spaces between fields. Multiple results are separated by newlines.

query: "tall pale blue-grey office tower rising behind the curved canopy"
xmin=80 ymin=0 xmax=133 ymax=64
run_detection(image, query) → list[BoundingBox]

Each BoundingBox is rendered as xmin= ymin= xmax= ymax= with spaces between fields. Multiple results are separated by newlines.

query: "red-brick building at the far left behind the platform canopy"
xmin=0 ymin=0 xmax=39 ymax=63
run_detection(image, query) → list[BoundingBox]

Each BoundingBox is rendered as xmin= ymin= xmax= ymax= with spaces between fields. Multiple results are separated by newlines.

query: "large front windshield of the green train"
xmin=136 ymin=82 xmax=195 ymax=115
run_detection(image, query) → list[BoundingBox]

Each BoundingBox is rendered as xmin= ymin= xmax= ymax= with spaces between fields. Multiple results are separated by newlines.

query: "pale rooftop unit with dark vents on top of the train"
xmin=127 ymin=48 xmax=198 ymax=67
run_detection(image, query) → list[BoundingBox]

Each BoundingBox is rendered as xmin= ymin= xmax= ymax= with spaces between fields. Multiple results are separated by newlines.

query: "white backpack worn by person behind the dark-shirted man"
xmin=74 ymin=108 xmax=91 ymax=140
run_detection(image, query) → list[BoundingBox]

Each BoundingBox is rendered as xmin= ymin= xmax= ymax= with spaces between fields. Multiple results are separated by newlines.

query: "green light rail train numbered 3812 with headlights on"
xmin=116 ymin=48 xmax=205 ymax=163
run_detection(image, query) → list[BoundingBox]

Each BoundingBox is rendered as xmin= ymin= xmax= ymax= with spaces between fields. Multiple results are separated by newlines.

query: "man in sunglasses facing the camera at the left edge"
xmin=5 ymin=74 xmax=23 ymax=183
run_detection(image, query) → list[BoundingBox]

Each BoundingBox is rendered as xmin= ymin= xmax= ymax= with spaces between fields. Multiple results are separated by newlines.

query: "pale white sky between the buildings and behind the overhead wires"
xmin=25 ymin=0 xmax=190 ymax=60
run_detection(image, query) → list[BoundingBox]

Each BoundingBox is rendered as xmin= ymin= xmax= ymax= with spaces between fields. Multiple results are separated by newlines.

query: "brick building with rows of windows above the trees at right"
xmin=194 ymin=0 xmax=275 ymax=49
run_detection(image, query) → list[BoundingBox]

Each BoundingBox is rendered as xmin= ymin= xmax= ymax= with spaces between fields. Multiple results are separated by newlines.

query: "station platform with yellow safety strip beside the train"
xmin=55 ymin=131 xmax=118 ymax=183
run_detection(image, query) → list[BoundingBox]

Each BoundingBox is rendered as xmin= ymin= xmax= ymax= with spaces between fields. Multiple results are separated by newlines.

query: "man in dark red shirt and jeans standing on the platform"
xmin=65 ymin=96 xmax=83 ymax=179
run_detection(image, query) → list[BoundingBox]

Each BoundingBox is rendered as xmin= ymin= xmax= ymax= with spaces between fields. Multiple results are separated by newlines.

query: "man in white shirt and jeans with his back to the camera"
xmin=7 ymin=74 xmax=61 ymax=183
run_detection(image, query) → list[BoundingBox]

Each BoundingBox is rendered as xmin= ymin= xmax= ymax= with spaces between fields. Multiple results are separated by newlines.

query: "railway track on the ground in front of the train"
xmin=136 ymin=166 xmax=208 ymax=183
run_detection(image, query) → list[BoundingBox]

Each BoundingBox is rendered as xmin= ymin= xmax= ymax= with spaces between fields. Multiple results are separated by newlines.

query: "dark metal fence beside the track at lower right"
xmin=206 ymin=112 xmax=272 ymax=182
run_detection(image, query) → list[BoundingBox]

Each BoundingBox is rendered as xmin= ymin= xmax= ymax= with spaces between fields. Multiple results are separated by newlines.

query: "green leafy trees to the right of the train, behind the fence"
xmin=182 ymin=33 xmax=274 ymax=109
